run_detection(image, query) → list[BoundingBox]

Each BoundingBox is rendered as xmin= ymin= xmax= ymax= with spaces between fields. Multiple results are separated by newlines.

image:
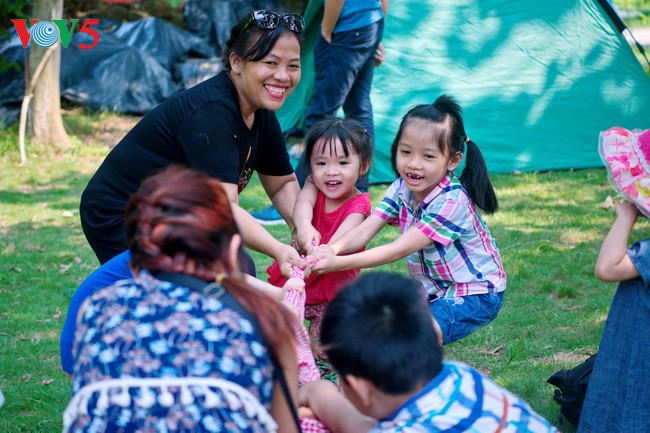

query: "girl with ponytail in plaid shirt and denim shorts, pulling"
xmin=312 ymin=95 xmax=506 ymax=343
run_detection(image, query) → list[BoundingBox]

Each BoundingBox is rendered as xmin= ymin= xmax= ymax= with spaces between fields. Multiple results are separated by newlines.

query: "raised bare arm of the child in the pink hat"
xmin=595 ymin=201 xmax=639 ymax=281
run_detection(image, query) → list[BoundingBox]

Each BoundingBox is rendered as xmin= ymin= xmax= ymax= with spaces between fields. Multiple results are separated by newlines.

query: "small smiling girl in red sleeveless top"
xmin=267 ymin=117 xmax=372 ymax=364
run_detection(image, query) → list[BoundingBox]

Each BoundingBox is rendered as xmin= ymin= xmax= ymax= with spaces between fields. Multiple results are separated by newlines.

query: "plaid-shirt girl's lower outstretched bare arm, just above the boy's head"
xmin=312 ymin=224 xmax=432 ymax=274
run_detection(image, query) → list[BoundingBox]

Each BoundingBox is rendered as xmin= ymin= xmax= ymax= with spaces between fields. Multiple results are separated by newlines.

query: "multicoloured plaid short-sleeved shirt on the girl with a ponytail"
xmin=373 ymin=173 xmax=506 ymax=298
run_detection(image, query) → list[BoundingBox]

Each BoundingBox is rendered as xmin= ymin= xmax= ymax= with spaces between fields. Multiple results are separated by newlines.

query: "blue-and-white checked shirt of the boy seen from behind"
xmin=369 ymin=362 xmax=558 ymax=433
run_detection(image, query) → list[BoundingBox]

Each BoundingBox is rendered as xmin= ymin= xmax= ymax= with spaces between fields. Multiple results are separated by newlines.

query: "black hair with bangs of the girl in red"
xmin=304 ymin=117 xmax=372 ymax=176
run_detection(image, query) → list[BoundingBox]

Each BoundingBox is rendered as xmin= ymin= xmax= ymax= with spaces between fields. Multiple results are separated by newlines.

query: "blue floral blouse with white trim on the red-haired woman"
xmin=64 ymin=271 xmax=273 ymax=432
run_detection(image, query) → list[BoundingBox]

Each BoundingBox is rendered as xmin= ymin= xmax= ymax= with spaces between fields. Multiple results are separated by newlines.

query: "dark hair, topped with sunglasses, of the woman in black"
xmin=221 ymin=11 xmax=303 ymax=71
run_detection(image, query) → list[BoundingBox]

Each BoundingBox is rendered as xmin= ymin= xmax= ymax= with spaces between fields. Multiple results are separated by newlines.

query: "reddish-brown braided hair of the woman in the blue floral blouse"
xmin=126 ymin=166 xmax=294 ymax=367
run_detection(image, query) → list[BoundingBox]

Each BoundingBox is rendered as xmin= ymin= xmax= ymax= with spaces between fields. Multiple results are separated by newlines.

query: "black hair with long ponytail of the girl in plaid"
xmin=391 ymin=95 xmax=499 ymax=213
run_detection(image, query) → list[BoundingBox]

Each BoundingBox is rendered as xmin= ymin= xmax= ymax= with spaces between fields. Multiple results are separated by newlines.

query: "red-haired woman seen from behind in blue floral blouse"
xmin=64 ymin=167 xmax=297 ymax=432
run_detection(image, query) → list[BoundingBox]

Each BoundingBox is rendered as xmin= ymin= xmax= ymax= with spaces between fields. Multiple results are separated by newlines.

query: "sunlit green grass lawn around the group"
xmin=0 ymin=114 xmax=650 ymax=433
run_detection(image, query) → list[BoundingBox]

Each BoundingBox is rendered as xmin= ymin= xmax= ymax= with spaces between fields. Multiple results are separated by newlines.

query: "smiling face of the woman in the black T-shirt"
xmin=231 ymin=32 xmax=301 ymax=118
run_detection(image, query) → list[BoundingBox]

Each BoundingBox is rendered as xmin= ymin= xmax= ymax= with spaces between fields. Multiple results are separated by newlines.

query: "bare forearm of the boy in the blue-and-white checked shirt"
xmin=299 ymin=380 xmax=377 ymax=433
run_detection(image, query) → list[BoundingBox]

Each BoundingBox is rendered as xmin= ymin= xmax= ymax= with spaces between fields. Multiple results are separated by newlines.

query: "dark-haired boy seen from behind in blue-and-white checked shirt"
xmin=300 ymin=272 xmax=557 ymax=433
